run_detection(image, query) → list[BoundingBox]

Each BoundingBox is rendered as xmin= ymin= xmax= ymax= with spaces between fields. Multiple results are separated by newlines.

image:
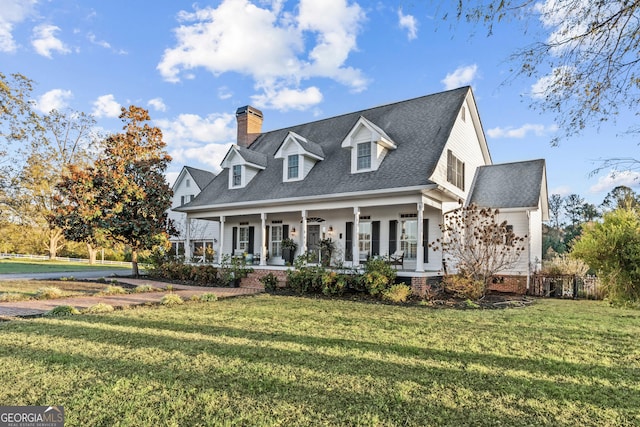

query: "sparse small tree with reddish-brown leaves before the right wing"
xmin=429 ymin=205 xmax=527 ymax=294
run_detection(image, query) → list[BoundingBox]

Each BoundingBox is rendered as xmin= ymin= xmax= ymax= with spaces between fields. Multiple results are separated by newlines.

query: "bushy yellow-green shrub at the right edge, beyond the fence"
xmin=571 ymin=209 xmax=640 ymax=303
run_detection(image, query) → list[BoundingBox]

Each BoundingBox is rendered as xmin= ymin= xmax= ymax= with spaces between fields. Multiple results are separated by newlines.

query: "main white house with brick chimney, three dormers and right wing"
xmin=176 ymin=87 xmax=548 ymax=290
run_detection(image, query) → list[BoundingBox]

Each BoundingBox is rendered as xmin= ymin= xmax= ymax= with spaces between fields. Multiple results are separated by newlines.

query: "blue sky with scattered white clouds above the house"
xmin=0 ymin=0 xmax=640 ymax=205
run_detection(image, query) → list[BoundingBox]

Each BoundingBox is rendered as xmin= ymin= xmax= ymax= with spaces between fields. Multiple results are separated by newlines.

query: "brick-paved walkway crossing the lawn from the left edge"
xmin=0 ymin=277 xmax=264 ymax=317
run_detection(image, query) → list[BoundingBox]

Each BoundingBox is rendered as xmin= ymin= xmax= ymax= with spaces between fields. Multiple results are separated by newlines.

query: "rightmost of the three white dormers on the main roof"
xmin=341 ymin=117 xmax=397 ymax=173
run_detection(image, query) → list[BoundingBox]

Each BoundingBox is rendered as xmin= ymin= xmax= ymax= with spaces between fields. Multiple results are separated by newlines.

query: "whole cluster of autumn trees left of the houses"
xmin=0 ymin=73 xmax=172 ymax=274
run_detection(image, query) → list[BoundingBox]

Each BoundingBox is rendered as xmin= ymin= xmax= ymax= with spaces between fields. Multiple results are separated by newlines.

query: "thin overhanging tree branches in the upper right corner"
xmin=450 ymin=0 xmax=640 ymax=143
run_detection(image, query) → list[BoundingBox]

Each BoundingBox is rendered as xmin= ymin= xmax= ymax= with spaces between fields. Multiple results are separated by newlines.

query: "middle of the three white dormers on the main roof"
xmin=274 ymin=132 xmax=324 ymax=182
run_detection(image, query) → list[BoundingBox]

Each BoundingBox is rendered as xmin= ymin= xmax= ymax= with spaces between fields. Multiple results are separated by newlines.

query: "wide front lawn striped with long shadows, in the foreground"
xmin=0 ymin=294 xmax=640 ymax=426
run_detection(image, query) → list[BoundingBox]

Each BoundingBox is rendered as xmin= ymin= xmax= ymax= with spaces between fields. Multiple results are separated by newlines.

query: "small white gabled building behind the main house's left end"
xmin=168 ymin=166 xmax=219 ymax=259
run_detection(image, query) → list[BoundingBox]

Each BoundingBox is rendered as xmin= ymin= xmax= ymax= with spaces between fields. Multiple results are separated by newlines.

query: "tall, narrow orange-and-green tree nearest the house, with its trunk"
xmin=92 ymin=105 xmax=172 ymax=275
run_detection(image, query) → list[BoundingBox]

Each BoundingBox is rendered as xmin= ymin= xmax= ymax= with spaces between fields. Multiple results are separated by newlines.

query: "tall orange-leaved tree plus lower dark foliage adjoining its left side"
xmin=56 ymin=105 xmax=172 ymax=275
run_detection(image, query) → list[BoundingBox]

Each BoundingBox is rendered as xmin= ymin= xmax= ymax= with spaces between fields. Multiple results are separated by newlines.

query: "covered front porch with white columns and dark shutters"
xmin=185 ymin=193 xmax=450 ymax=277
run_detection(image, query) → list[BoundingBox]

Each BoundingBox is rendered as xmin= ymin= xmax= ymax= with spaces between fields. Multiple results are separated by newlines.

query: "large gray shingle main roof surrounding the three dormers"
xmin=182 ymin=86 xmax=471 ymax=210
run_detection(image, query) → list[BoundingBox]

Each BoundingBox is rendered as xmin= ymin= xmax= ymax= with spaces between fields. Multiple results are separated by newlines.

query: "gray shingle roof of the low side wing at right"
xmin=467 ymin=159 xmax=545 ymax=208
